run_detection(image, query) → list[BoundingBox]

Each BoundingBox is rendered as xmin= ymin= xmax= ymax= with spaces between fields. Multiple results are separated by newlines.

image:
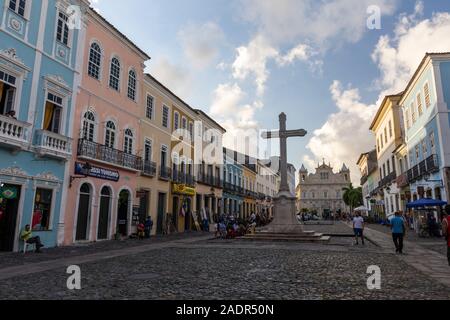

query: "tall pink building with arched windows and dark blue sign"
xmin=60 ymin=10 xmax=150 ymax=245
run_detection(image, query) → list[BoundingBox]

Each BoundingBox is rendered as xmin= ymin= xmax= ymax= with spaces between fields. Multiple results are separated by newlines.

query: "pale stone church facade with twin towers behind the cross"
xmin=296 ymin=161 xmax=351 ymax=218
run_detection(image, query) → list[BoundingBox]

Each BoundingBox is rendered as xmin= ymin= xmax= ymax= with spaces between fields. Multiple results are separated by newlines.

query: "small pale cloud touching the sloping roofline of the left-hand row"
xmin=150 ymin=58 xmax=193 ymax=99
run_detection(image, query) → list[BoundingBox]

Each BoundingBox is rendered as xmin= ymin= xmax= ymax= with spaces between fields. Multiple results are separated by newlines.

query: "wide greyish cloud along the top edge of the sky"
xmin=241 ymin=0 xmax=399 ymax=48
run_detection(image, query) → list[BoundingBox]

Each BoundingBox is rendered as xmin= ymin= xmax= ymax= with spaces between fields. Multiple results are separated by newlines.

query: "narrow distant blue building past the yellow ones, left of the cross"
xmin=222 ymin=149 xmax=245 ymax=217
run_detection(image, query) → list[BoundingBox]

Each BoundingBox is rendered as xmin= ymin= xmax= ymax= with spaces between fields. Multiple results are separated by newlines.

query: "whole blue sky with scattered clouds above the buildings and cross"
xmin=93 ymin=0 xmax=450 ymax=181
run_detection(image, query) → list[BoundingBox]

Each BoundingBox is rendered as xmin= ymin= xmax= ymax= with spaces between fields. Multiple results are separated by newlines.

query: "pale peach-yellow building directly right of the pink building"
xmin=138 ymin=74 xmax=172 ymax=234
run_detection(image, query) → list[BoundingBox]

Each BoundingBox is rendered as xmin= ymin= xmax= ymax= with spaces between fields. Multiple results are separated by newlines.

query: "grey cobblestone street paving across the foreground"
xmin=0 ymin=223 xmax=450 ymax=300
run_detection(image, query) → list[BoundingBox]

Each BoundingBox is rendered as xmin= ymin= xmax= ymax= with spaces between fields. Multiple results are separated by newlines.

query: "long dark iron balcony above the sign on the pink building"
xmin=77 ymin=139 xmax=143 ymax=171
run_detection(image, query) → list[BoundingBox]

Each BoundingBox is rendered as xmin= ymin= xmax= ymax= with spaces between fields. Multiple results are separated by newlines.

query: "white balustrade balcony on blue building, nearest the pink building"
xmin=35 ymin=130 xmax=72 ymax=161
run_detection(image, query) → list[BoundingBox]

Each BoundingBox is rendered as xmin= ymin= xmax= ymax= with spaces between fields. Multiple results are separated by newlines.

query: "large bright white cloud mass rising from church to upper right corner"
xmin=303 ymin=2 xmax=450 ymax=184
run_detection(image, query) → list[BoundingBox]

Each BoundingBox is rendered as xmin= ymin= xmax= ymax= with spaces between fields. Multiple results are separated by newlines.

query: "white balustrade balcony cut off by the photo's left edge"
xmin=0 ymin=115 xmax=31 ymax=149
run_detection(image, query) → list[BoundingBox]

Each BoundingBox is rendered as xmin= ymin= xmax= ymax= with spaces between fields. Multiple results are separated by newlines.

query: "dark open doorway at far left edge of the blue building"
xmin=0 ymin=184 xmax=20 ymax=251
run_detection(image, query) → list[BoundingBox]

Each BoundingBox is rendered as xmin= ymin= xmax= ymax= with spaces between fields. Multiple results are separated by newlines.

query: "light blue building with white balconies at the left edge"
xmin=0 ymin=0 xmax=89 ymax=251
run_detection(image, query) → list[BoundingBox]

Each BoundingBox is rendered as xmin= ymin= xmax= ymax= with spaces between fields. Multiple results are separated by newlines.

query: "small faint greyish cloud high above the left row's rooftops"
xmin=178 ymin=22 xmax=225 ymax=69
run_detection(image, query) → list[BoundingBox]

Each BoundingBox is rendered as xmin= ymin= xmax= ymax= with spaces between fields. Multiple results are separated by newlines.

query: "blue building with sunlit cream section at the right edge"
xmin=400 ymin=53 xmax=450 ymax=200
